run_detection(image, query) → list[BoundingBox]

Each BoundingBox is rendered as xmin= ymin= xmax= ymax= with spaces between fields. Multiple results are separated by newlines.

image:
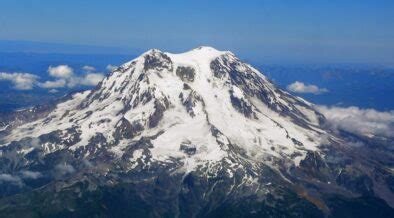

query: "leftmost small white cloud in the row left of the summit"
xmin=0 ymin=73 xmax=39 ymax=90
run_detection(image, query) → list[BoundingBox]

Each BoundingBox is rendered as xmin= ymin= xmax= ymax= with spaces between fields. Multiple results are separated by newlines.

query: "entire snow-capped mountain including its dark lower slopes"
xmin=0 ymin=47 xmax=394 ymax=216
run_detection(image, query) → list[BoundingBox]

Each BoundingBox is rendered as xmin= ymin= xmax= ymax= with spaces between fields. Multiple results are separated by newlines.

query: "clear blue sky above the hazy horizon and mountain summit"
xmin=0 ymin=0 xmax=394 ymax=66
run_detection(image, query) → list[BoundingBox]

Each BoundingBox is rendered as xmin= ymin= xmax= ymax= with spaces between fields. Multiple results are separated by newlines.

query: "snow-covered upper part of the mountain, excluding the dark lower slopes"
xmin=5 ymin=47 xmax=327 ymax=167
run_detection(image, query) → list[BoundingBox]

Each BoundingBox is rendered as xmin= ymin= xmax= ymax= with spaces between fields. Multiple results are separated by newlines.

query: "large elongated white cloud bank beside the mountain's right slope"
xmin=316 ymin=106 xmax=394 ymax=137
